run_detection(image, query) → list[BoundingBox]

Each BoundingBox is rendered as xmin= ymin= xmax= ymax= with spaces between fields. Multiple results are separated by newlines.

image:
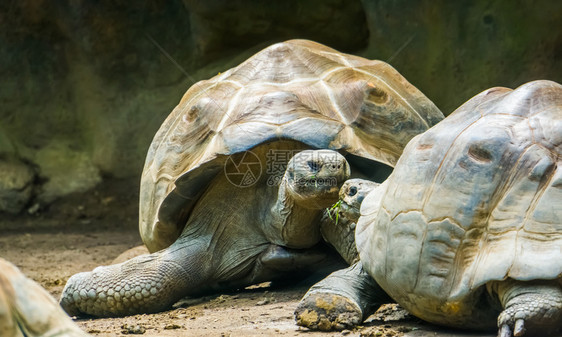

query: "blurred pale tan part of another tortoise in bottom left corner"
xmin=0 ymin=258 xmax=87 ymax=337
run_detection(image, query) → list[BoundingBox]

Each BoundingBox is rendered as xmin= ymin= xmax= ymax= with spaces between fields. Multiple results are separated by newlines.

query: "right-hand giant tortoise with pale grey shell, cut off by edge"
xmin=296 ymin=81 xmax=562 ymax=337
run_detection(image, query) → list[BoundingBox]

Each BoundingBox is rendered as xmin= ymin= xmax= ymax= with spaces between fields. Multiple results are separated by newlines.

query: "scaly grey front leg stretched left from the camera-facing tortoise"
xmin=60 ymin=240 xmax=209 ymax=317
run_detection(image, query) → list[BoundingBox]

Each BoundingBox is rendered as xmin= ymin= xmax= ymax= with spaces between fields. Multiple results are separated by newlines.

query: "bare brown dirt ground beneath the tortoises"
xmin=0 ymin=180 xmax=495 ymax=337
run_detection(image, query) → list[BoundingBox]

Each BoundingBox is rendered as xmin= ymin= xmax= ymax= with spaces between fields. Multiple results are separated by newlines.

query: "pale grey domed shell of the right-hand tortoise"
xmin=356 ymin=81 xmax=562 ymax=320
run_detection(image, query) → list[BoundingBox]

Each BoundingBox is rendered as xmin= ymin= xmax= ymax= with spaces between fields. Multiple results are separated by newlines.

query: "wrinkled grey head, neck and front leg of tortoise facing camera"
xmin=60 ymin=148 xmax=350 ymax=316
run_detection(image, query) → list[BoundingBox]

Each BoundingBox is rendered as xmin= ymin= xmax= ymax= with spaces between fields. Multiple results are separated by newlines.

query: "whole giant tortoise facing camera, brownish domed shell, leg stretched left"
xmin=61 ymin=40 xmax=443 ymax=316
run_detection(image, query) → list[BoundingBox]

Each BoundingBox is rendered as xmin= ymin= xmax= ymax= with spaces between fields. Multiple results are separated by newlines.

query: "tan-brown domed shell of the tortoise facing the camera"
xmin=139 ymin=40 xmax=443 ymax=251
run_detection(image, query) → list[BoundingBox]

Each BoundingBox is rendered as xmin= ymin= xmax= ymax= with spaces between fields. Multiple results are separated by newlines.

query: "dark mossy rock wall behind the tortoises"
xmin=0 ymin=0 xmax=562 ymax=213
